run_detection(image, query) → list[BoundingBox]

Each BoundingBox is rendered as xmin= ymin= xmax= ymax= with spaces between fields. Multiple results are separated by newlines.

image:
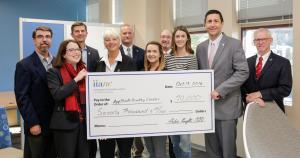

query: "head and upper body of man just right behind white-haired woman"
xmin=120 ymin=24 xmax=144 ymax=71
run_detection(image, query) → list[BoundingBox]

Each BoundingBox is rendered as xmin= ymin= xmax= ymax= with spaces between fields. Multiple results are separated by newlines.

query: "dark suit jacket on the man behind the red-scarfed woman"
xmin=86 ymin=46 xmax=100 ymax=72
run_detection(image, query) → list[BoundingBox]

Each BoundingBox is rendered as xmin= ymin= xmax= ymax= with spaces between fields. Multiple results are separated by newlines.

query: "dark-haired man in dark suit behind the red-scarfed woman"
xmin=71 ymin=22 xmax=100 ymax=72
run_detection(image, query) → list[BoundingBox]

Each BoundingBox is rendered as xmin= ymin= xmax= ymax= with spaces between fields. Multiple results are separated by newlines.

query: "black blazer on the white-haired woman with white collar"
xmin=96 ymin=54 xmax=137 ymax=72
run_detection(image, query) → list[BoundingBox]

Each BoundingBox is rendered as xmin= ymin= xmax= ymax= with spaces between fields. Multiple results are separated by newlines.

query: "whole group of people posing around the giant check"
xmin=15 ymin=10 xmax=292 ymax=158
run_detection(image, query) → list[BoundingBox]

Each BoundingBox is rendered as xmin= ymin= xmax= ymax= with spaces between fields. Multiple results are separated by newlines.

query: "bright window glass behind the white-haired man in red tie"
xmin=242 ymin=26 xmax=293 ymax=105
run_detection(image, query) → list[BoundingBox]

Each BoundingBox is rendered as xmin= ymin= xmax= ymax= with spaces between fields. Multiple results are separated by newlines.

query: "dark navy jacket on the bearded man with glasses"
xmin=14 ymin=52 xmax=54 ymax=135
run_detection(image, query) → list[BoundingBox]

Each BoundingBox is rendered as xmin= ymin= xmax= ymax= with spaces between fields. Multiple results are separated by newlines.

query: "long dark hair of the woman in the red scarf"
xmin=53 ymin=39 xmax=82 ymax=68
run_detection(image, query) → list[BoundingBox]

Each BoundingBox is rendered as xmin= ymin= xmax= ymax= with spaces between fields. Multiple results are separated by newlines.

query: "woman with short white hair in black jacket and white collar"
xmin=96 ymin=30 xmax=137 ymax=158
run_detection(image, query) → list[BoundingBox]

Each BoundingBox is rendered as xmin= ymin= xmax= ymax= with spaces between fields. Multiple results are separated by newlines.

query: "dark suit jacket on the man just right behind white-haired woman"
xmin=120 ymin=45 xmax=145 ymax=71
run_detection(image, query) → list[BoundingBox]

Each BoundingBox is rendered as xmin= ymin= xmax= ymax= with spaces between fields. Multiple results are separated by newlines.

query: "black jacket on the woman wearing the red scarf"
xmin=47 ymin=68 xmax=81 ymax=130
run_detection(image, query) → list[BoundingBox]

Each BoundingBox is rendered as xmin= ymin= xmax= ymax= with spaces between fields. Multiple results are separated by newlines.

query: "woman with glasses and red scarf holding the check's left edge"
xmin=47 ymin=40 xmax=89 ymax=158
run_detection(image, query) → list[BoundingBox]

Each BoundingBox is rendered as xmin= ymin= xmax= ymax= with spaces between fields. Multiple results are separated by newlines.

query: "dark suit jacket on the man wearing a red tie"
xmin=242 ymin=51 xmax=292 ymax=111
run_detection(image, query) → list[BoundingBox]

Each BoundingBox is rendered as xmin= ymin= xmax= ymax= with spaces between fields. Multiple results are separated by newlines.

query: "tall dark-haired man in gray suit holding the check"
xmin=196 ymin=10 xmax=249 ymax=158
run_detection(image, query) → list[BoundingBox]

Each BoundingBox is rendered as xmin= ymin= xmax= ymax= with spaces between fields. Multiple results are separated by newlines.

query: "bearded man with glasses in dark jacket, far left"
xmin=14 ymin=26 xmax=56 ymax=158
